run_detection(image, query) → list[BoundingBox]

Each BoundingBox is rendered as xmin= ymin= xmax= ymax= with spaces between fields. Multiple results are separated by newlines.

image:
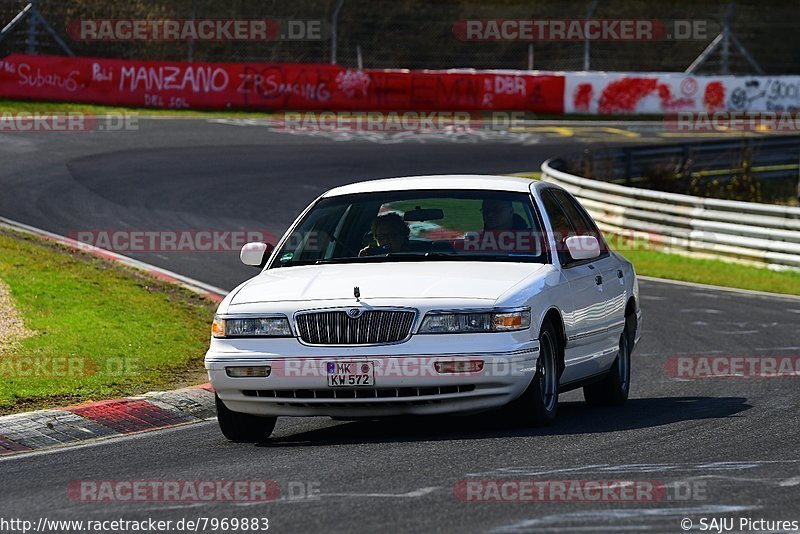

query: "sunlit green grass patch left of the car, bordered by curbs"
xmin=0 ymin=230 xmax=215 ymax=413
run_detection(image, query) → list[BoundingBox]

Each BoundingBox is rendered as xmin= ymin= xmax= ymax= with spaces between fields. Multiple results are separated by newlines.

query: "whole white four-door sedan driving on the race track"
xmin=205 ymin=175 xmax=641 ymax=441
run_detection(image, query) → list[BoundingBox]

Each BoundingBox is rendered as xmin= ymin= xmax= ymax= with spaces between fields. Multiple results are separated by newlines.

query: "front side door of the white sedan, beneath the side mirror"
xmin=541 ymin=188 xmax=608 ymax=384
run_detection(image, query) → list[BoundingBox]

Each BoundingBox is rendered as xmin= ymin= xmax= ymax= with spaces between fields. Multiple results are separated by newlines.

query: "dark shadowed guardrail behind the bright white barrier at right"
xmin=571 ymin=136 xmax=800 ymax=201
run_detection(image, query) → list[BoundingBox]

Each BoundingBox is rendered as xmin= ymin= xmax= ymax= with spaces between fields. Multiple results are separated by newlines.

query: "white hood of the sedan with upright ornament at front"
xmin=230 ymin=261 xmax=544 ymax=305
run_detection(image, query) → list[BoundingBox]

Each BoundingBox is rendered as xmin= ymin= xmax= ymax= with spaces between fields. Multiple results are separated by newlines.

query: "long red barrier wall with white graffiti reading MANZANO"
xmin=0 ymin=55 xmax=564 ymax=114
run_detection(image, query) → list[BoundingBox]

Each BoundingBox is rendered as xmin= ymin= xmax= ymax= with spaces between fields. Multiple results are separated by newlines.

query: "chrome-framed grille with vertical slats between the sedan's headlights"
xmin=297 ymin=310 xmax=416 ymax=345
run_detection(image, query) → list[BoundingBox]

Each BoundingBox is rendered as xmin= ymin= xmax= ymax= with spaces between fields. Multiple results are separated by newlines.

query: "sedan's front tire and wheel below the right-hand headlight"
xmin=509 ymin=323 xmax=559 ymax=426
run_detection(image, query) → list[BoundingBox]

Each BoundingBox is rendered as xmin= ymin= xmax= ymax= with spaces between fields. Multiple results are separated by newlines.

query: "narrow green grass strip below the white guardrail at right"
xmin=606 ymin=236 xmax=800 ymax=295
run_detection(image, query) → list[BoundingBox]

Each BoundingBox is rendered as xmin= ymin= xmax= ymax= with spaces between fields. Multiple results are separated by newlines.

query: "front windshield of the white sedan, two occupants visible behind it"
xmin=270 ymin=190 xmax=547 ymax=268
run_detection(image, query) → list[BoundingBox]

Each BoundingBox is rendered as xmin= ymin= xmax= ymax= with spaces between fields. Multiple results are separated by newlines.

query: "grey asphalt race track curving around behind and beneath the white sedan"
xmin=0 ymin=119 xmax=800 ymax=532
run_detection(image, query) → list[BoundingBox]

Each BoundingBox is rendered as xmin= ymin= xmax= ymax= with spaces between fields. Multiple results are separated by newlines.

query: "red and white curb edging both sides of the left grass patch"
xmin=0 ymin=217 xmax=227 ymax=457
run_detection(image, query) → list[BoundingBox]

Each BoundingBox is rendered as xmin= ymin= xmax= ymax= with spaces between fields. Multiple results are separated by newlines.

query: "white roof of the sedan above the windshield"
xmin=322 ymin=174 xmax=531 ymax=197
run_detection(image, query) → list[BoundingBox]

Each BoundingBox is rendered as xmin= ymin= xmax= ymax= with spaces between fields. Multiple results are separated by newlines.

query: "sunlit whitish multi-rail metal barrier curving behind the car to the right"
xmin=542 ymin=159 xmax=800 ymax=269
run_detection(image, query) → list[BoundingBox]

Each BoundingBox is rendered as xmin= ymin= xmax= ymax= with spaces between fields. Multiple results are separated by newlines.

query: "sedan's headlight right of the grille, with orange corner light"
xmin=419 ymin=310 xmax=531 ymax=334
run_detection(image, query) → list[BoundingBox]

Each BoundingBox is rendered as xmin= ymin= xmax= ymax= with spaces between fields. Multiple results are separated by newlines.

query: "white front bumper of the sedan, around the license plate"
xmin=206 ymin=341 xmax=539 ymax=418
